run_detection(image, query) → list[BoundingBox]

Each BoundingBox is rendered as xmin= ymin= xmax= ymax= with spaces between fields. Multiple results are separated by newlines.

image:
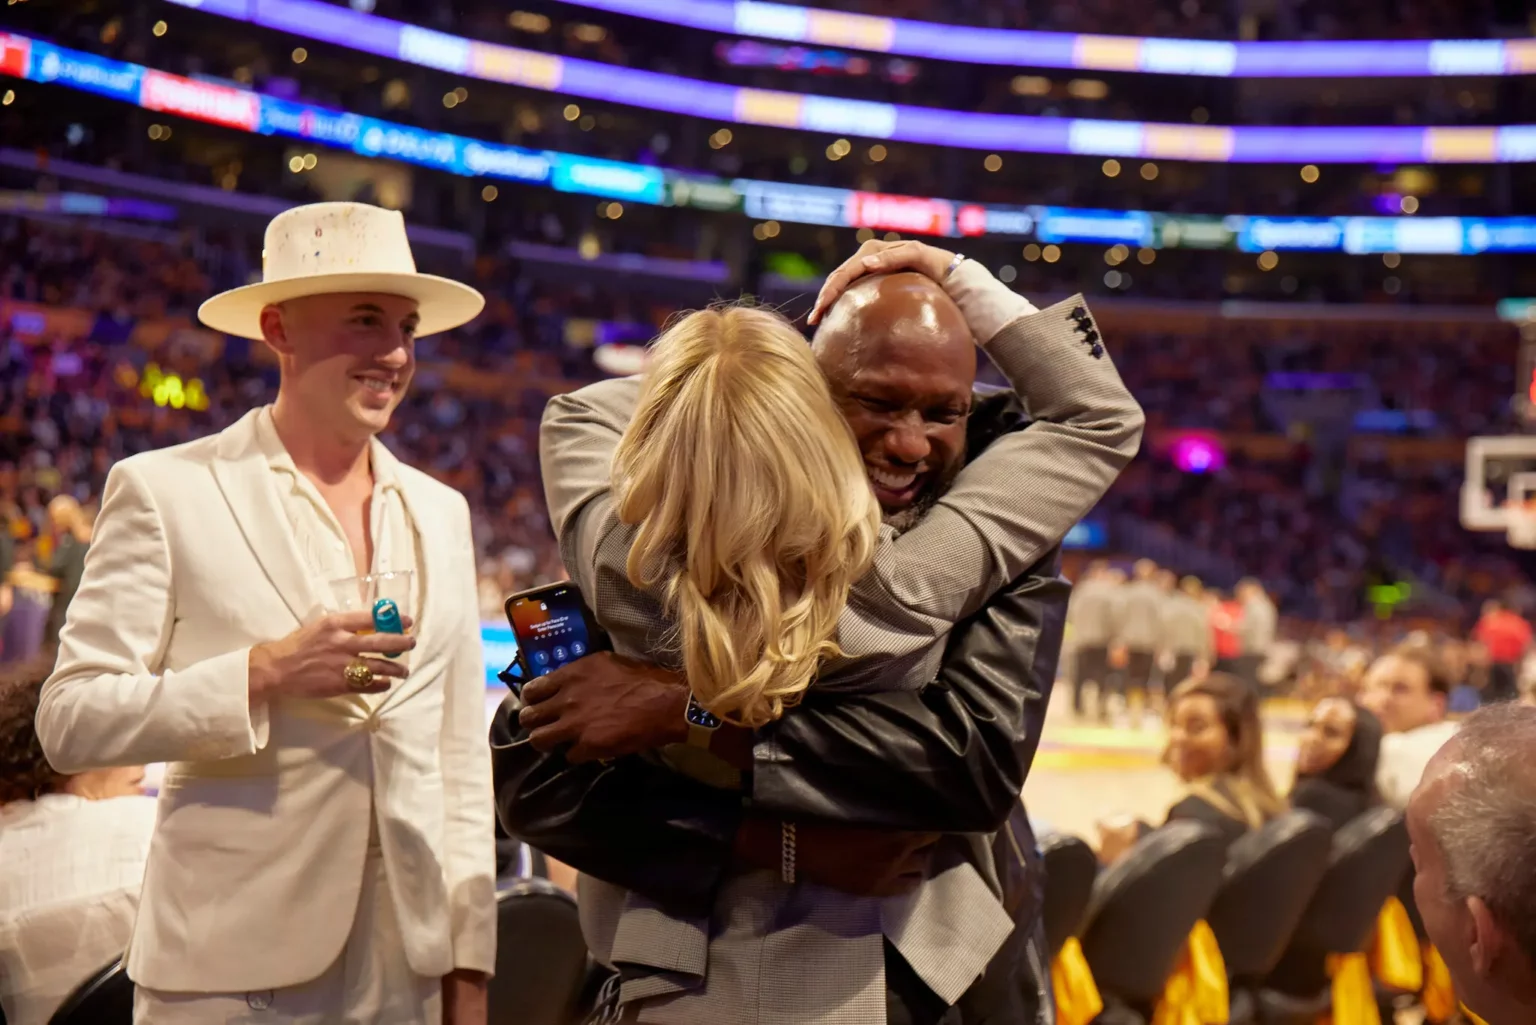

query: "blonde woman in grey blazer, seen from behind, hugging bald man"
xmin=541 ymin=238 xmax=1141 ymax=1023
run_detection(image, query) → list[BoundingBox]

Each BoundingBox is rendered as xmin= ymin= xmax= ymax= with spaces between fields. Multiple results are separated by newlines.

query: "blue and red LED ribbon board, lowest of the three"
xmin=12 ymin=32 xmax=1536 ymax=255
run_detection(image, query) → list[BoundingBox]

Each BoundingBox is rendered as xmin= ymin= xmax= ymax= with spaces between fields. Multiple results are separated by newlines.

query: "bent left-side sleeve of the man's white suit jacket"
xmin=37 ymin=461 xmax=267 ymax=773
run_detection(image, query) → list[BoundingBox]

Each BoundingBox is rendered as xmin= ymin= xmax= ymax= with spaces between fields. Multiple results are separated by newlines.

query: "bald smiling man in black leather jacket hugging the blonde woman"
xmin=492 ymin=247 xmax=1140 ymax=1025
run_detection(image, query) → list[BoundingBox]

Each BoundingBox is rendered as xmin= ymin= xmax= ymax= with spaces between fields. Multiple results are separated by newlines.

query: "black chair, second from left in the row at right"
xmin=1083 ymin=822 xmax=1226 ymax=1022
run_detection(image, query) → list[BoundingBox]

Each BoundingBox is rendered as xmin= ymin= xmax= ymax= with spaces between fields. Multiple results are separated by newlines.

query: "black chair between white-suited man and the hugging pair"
xmin=488 ymin=879 xmax=587 ymax=1025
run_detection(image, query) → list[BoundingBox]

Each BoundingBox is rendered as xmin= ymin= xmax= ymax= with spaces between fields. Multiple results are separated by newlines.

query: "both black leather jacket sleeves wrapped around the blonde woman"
xmin=492 ymin=555 xmax=1069 ymax=904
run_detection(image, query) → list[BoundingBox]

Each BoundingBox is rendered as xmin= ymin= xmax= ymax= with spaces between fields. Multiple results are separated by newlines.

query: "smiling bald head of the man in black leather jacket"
xmin=813 ymin=274 xmax=975 ymax=530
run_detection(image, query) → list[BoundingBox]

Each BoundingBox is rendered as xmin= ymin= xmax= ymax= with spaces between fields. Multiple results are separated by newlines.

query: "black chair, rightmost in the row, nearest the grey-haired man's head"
xmin=1260 ymin=808 xmax=1409 ymax=1025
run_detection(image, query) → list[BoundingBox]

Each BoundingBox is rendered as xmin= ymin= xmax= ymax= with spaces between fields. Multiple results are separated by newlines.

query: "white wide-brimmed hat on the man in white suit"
xmin=197 ymin=203 xmax=485 ymax=340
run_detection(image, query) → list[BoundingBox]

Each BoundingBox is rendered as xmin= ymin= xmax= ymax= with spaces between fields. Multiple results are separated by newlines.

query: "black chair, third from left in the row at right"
xmin=1206 ymin=811 xmax=1333 ymax=1025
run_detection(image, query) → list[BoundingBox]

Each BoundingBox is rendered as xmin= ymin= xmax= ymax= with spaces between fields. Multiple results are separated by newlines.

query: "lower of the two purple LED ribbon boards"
xmin=158 ymin=0 xmax=1536 ymax=164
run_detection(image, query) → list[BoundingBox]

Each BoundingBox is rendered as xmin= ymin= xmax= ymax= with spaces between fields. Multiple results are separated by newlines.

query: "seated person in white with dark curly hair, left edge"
xmin=0 ymin=661 xmax=155 ymax=1025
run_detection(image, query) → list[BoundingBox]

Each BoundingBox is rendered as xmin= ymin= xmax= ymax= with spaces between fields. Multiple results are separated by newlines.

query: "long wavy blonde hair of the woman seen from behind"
xmin=613 ymin=306 xmax=880 ymax=725
